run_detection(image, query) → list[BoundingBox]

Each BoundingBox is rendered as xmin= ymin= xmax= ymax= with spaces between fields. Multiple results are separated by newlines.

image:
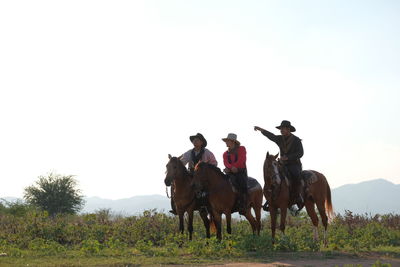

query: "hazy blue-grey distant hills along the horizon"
xmin=0 ymin=179 xmax=400 ymax=215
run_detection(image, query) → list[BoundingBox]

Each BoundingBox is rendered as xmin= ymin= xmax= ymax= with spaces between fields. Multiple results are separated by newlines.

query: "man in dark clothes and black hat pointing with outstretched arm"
xmin=254 ymin=120 xmax=304 ymax=214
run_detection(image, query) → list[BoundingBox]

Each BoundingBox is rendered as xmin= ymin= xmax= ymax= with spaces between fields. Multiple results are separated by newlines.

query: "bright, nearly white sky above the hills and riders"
xmin=0 ymin=0 xmax=400 ymax=199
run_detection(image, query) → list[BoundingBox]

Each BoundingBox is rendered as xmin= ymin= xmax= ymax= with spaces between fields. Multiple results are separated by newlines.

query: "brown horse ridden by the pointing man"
xmin=264 ymin=153 xmax=333 ymax=246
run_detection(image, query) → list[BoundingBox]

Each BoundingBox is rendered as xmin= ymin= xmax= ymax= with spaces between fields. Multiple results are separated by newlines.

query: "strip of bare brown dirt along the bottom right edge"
xmin=208 ymin=258 xmax=400 ymax=267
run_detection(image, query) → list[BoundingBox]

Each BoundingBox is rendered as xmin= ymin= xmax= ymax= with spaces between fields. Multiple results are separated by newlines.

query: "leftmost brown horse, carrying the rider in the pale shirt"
xmin=164 ymin=155 xmax=210 ymax=240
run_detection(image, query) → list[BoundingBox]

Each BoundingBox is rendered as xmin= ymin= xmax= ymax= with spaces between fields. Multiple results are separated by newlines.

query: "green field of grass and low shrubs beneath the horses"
xmin=0 ymin=205 xmax=400 ymax=266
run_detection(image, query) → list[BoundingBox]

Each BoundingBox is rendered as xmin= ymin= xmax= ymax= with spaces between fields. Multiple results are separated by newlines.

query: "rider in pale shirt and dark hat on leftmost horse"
xmin=169 ymin=133 xmax=218 ymax=215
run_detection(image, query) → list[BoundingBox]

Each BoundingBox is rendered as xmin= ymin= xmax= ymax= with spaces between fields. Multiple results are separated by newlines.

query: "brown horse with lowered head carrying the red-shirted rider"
xmin=194 ymin=162 xmax=263 ymax=240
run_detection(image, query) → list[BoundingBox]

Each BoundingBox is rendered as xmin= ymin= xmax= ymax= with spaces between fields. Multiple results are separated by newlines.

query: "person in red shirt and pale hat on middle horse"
xmin=222 ymin=133 xmax=247 ymax=215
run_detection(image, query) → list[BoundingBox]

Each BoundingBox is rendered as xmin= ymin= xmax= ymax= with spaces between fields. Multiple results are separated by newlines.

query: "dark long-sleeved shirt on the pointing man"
xmin=261 ymin=130 xmax=304 ymax=164
